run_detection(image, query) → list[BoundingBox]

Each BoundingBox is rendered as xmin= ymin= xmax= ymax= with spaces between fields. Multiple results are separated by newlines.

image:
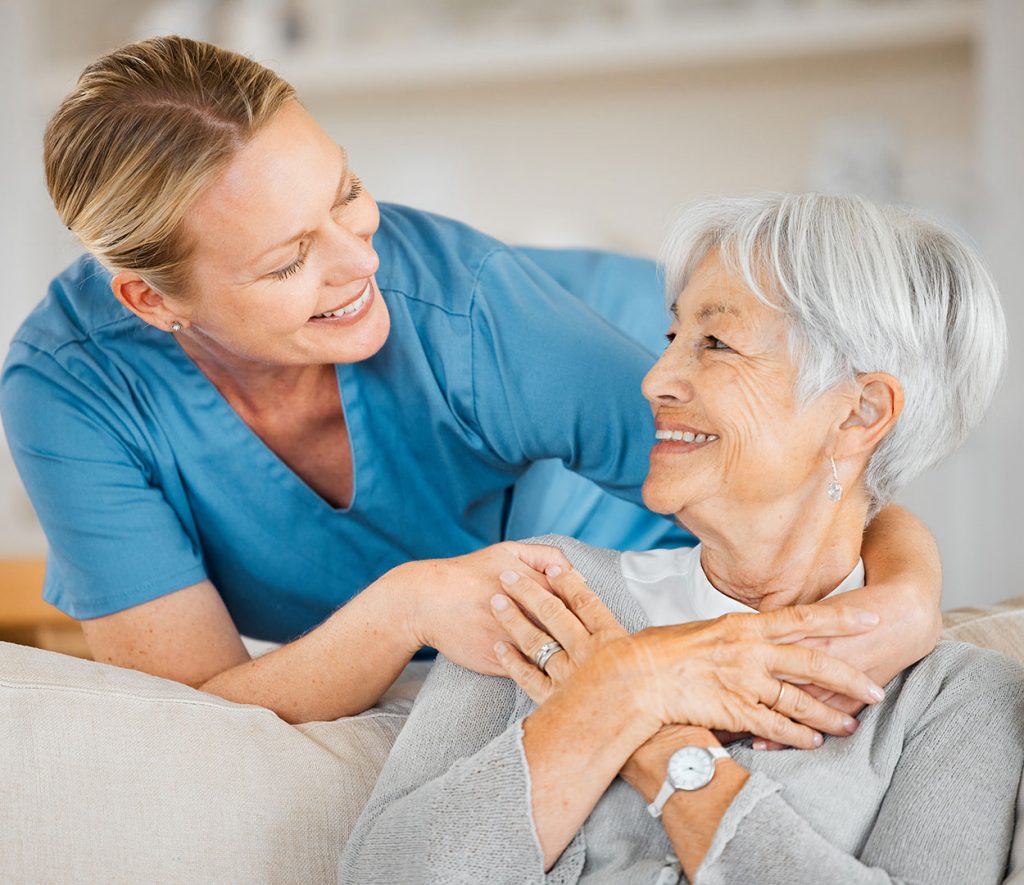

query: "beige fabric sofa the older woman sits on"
xmin=0 ymin=597 xmax=1024 ymax=885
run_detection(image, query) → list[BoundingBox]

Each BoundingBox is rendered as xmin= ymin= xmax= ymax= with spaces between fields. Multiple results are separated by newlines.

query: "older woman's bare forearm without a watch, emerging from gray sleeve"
xmin=522 ymin=671 xmax=651 ymax=870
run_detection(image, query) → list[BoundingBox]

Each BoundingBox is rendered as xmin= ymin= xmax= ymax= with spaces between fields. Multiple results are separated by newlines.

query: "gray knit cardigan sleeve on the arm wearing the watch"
xmin=696 ymin=659 xmax=1024 ymax=885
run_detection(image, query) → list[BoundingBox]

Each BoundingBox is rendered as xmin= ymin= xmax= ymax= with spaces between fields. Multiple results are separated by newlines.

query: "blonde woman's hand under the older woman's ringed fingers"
xmin=392 ymin=541 xmax=570 ymax=676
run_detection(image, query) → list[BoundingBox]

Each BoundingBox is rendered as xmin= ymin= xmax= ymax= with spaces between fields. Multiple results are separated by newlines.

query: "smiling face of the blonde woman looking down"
xmin=177 ymin=101 xmax=390 ymax=366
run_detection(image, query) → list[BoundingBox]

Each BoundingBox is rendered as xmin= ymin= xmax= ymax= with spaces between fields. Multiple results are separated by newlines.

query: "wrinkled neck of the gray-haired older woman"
xmin=679 ymin=482 xmax=867 ymax=612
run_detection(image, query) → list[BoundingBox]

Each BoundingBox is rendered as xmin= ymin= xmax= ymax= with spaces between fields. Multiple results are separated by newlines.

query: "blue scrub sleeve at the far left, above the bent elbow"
xmin=2 ymin=342 xmax=206 ymax=620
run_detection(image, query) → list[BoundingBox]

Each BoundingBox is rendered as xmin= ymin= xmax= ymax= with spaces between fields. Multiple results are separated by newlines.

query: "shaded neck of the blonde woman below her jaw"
xmin=177 ymin=333 xmax=334 ymax=417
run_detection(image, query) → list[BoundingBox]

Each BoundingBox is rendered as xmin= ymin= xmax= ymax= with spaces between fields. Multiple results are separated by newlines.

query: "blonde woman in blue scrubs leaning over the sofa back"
xmin=2 ymin=37 xmax=939 ymax=725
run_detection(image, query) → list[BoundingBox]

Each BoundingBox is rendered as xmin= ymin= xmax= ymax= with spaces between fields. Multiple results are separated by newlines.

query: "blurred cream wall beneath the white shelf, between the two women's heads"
xmin=315 ymin=45 xmax=975 ymax=254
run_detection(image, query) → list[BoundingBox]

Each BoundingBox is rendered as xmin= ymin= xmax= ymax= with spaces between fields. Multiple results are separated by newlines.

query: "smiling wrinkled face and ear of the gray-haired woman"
xmin=643 ymin=253 xmax=853 ymax=529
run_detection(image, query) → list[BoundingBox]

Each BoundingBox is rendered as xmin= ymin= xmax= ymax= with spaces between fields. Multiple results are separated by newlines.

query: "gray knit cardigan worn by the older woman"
xmin=339 ymin=536 xmax=1024 ymax=885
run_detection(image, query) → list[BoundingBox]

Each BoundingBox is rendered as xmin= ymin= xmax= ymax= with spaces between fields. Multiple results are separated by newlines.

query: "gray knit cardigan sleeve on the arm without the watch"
xmin=339 ymin=658 xmax=584 ymax=883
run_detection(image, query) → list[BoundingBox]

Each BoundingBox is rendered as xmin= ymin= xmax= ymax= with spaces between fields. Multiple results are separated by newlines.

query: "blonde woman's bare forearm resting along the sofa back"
xmin=199 ymin=573 xmax=417 ymax=723
